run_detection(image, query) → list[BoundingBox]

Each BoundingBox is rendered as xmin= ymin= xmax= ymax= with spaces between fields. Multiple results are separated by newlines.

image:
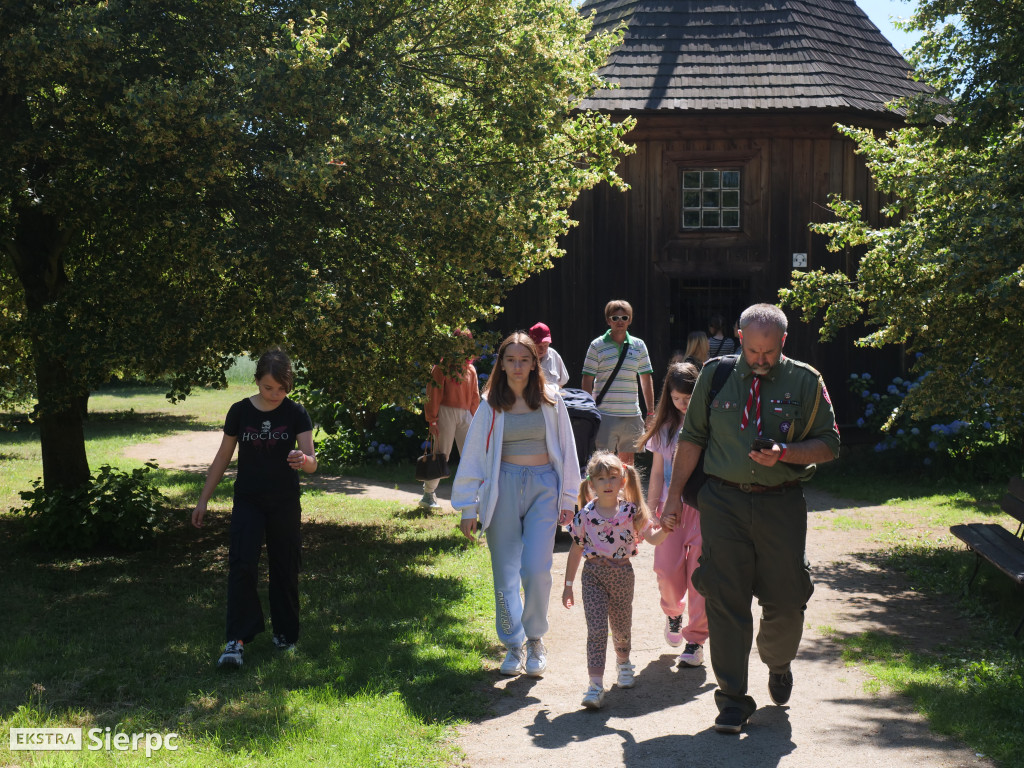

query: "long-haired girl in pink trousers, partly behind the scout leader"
xmin=640 ymin=362 xmax=708 ymax=667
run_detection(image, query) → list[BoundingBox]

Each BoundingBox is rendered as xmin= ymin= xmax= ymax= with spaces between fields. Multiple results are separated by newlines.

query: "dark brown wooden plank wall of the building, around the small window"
xmin=495 ymin=113 xmax=901 ymax=422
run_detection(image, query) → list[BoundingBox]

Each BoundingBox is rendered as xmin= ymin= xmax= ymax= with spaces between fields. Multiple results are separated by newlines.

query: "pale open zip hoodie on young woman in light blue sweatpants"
xmin=452 ymin=385 xmax=580 ymax=530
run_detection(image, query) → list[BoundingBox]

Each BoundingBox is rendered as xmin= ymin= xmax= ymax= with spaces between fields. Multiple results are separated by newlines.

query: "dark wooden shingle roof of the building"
xmin=580 ymin=0 xmax=928 ymax=113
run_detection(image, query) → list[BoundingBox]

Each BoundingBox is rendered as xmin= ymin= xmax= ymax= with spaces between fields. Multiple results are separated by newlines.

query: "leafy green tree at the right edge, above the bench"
xmin=782 ymin=0 xmax=1024 ymax=431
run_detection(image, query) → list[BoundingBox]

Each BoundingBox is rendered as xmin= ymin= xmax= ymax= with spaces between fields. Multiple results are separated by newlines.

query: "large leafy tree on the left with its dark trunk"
xmin=0 ymin=0 xmax=629 ymax=487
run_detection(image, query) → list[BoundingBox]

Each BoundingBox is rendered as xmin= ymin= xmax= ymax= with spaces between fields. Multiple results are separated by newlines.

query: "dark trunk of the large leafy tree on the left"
xmin=4 ymin=207 xmax=89 ymax=490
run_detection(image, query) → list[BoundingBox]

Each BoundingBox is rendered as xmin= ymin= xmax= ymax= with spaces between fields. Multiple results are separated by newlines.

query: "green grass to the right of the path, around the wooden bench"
xmin=814 ymin=456 xmax=1024 ymax=768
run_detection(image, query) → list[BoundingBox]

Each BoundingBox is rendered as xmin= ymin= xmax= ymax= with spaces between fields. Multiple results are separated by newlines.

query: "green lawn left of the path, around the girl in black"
xmin=0 ymin=385 xmax=498 ymax=768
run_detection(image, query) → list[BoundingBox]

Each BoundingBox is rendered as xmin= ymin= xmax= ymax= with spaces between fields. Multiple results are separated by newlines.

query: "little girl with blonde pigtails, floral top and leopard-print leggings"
xmin=562 ymin=451 xmax=669 ymax=710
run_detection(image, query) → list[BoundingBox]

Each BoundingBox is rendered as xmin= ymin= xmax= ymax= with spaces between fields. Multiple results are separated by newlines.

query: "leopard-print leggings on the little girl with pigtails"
xmin=581 ymin=557 xmax=634 ymax=675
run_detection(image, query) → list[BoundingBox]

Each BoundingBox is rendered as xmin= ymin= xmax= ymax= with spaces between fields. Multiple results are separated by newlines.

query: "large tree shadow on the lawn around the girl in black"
xmin=0 ymin=507 xmax=487 ymax=751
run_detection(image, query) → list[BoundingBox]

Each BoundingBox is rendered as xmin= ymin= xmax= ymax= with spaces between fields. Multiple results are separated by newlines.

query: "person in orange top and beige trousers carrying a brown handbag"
xmin=420 ymin=331 xmax=480 ymax=511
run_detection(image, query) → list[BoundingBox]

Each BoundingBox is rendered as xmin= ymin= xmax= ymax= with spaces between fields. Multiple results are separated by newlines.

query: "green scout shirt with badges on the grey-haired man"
xmin=679 ymin=355 xmax=839 ymax=485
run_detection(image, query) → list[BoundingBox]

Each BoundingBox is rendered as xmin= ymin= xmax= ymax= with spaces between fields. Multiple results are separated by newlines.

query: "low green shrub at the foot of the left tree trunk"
xmin=11 ymin=464 xmax=170 ymax=551
